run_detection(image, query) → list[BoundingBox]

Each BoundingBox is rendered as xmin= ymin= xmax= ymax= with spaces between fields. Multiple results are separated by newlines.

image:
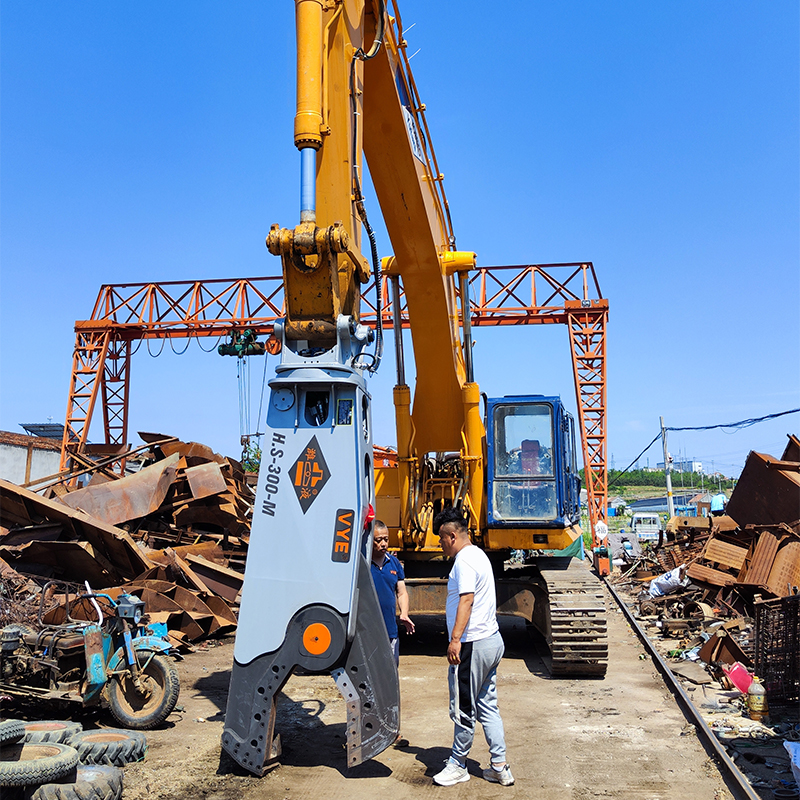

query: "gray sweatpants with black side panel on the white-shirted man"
xmin=448 ymin=632 xmax=506 ymax=767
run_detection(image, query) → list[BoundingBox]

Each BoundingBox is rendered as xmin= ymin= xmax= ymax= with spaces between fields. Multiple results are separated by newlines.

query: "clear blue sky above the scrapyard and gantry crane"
xmin=0 ymin=0 xmax=800 ymax=475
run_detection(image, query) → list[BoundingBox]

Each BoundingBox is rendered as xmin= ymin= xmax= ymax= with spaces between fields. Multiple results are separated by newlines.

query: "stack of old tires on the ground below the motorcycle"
xmin=0 ymin=719 xmax=147 ymax=800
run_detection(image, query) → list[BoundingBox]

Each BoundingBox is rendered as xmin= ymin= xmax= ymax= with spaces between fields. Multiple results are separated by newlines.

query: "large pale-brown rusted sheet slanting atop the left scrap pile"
xmin=61 ymin=455 xmax=179 ymax=525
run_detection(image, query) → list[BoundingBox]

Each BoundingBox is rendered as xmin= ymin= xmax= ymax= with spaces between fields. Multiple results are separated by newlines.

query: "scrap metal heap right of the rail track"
xmin=612 ymin=436 xmax=800 ymax=709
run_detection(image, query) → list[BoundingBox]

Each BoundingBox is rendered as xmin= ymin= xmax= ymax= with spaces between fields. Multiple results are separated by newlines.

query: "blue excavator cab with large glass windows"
xmin=486 ymin=395 xmax=580 ymax=529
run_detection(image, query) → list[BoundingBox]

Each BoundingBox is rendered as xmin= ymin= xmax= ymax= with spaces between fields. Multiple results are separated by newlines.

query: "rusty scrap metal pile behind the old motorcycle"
xmin=0 ymin=434 xmax=254 ymax=646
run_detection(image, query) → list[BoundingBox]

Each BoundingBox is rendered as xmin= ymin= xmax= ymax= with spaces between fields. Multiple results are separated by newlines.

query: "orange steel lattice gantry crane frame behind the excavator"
xmin=61 ymin=262 xmax=608 ymax=530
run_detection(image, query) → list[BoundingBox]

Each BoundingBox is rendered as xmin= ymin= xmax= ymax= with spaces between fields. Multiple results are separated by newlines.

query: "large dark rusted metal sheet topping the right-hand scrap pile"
xmin=727 ymin=452 xmax=800 ymax=527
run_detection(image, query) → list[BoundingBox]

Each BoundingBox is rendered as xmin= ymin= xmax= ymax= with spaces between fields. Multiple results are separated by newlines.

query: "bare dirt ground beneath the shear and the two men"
xmin=90 ymin=584 xmax=740 ymax=800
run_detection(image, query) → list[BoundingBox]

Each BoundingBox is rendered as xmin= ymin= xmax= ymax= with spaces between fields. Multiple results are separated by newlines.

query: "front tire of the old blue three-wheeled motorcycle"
xmin=106 ymin=652 xmax=181 ymax=731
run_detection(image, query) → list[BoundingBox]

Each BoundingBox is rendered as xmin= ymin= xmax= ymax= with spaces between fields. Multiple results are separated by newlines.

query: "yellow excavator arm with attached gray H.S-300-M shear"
xmin=222 ymin=0 xmax=482 ymax=775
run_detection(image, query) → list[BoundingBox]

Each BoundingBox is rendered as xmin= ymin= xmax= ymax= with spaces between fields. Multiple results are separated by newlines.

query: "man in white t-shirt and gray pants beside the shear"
xmin=433 ymin=508 xmax=514 ymax=786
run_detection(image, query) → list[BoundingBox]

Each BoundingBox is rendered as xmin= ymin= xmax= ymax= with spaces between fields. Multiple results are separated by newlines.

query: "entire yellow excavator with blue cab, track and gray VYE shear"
xmin=222 ymin=0 xmax=607 ymax=774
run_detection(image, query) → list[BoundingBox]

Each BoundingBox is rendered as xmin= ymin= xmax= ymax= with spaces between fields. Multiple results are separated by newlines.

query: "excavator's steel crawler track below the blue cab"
xmin=539 ymin=558 xmax=608 ymax=678
